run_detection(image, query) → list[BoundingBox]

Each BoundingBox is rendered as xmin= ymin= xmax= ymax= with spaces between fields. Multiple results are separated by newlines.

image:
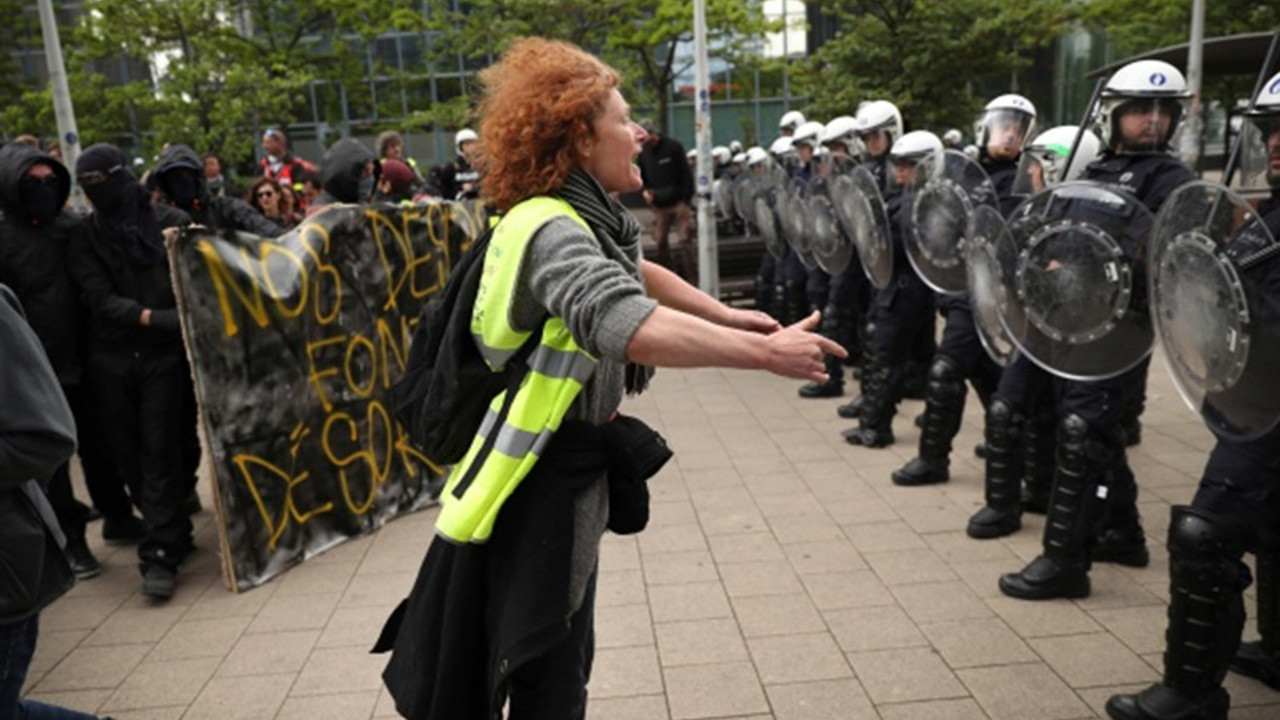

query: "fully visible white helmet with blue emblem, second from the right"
xmin=1093 ymin=60 xmax=1190 ymax=152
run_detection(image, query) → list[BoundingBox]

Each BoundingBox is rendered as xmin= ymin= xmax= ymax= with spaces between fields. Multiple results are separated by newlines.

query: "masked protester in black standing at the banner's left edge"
xmin=69 ymin=145 xmax=195 ymax=600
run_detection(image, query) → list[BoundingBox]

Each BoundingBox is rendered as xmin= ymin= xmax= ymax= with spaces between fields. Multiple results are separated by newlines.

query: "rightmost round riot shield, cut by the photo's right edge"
xmin=1148 ymin=182 xmax=1280 ymax=439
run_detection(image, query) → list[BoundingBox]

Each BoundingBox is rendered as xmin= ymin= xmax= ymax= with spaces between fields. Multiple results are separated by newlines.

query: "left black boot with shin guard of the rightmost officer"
xmin=1107 ymin=506 xmax=1248 ymax=720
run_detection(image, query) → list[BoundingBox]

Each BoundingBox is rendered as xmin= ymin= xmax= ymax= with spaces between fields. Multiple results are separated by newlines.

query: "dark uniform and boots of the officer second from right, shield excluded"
xmin=1000 ymin=152 xmax=1193 ymax=600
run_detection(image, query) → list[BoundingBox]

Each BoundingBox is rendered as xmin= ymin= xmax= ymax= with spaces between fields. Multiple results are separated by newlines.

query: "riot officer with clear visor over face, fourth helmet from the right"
xmin=892 ymin=94 xmax=1036 ymax=486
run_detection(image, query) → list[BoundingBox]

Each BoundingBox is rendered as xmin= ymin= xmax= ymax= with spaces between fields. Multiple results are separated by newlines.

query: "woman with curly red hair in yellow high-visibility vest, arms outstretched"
xmin=373 ymin=38 xmax=844 ymax=720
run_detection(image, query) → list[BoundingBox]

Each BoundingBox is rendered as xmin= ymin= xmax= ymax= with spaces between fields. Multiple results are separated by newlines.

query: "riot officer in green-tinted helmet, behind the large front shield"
xmin=965 ymin=126 xmax=1102 ymax=539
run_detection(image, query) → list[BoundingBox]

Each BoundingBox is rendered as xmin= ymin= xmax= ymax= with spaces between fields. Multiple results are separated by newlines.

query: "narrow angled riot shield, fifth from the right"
xmin=828 ymin=165 xmax=893 ymax=288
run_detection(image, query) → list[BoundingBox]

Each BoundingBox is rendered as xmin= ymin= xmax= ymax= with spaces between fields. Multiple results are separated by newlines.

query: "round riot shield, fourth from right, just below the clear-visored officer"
xmin=904 ymin=150 xmax=996 ymax=292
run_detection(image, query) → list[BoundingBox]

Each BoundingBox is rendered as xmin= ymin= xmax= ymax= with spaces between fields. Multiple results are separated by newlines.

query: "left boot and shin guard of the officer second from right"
xmin=1000 ymin=414 xmax=1105 ymax=600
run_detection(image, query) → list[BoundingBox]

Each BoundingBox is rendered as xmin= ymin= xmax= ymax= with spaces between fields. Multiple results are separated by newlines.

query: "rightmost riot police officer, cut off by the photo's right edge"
xmin=1107 ymin=74 xmax=1280 ymax=720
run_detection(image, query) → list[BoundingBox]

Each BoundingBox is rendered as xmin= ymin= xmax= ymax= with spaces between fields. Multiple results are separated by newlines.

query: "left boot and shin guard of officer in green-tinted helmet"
xmin=965 ymin=395 xmax=1023 ymax=539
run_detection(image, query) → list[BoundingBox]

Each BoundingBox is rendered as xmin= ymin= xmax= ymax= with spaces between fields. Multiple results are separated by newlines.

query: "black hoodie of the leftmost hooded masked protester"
xmin=0 ymin=142 xmax=87 ymax=386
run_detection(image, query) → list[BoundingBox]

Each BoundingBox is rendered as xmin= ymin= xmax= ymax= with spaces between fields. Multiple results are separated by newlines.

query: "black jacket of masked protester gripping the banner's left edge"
xmin=69 ymin=197 xmax=191 ymax=354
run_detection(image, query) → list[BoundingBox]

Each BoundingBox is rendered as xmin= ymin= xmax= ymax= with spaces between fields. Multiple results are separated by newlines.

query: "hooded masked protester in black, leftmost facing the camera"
xmin=0 ymin=143 xmax=141 ymax=578
